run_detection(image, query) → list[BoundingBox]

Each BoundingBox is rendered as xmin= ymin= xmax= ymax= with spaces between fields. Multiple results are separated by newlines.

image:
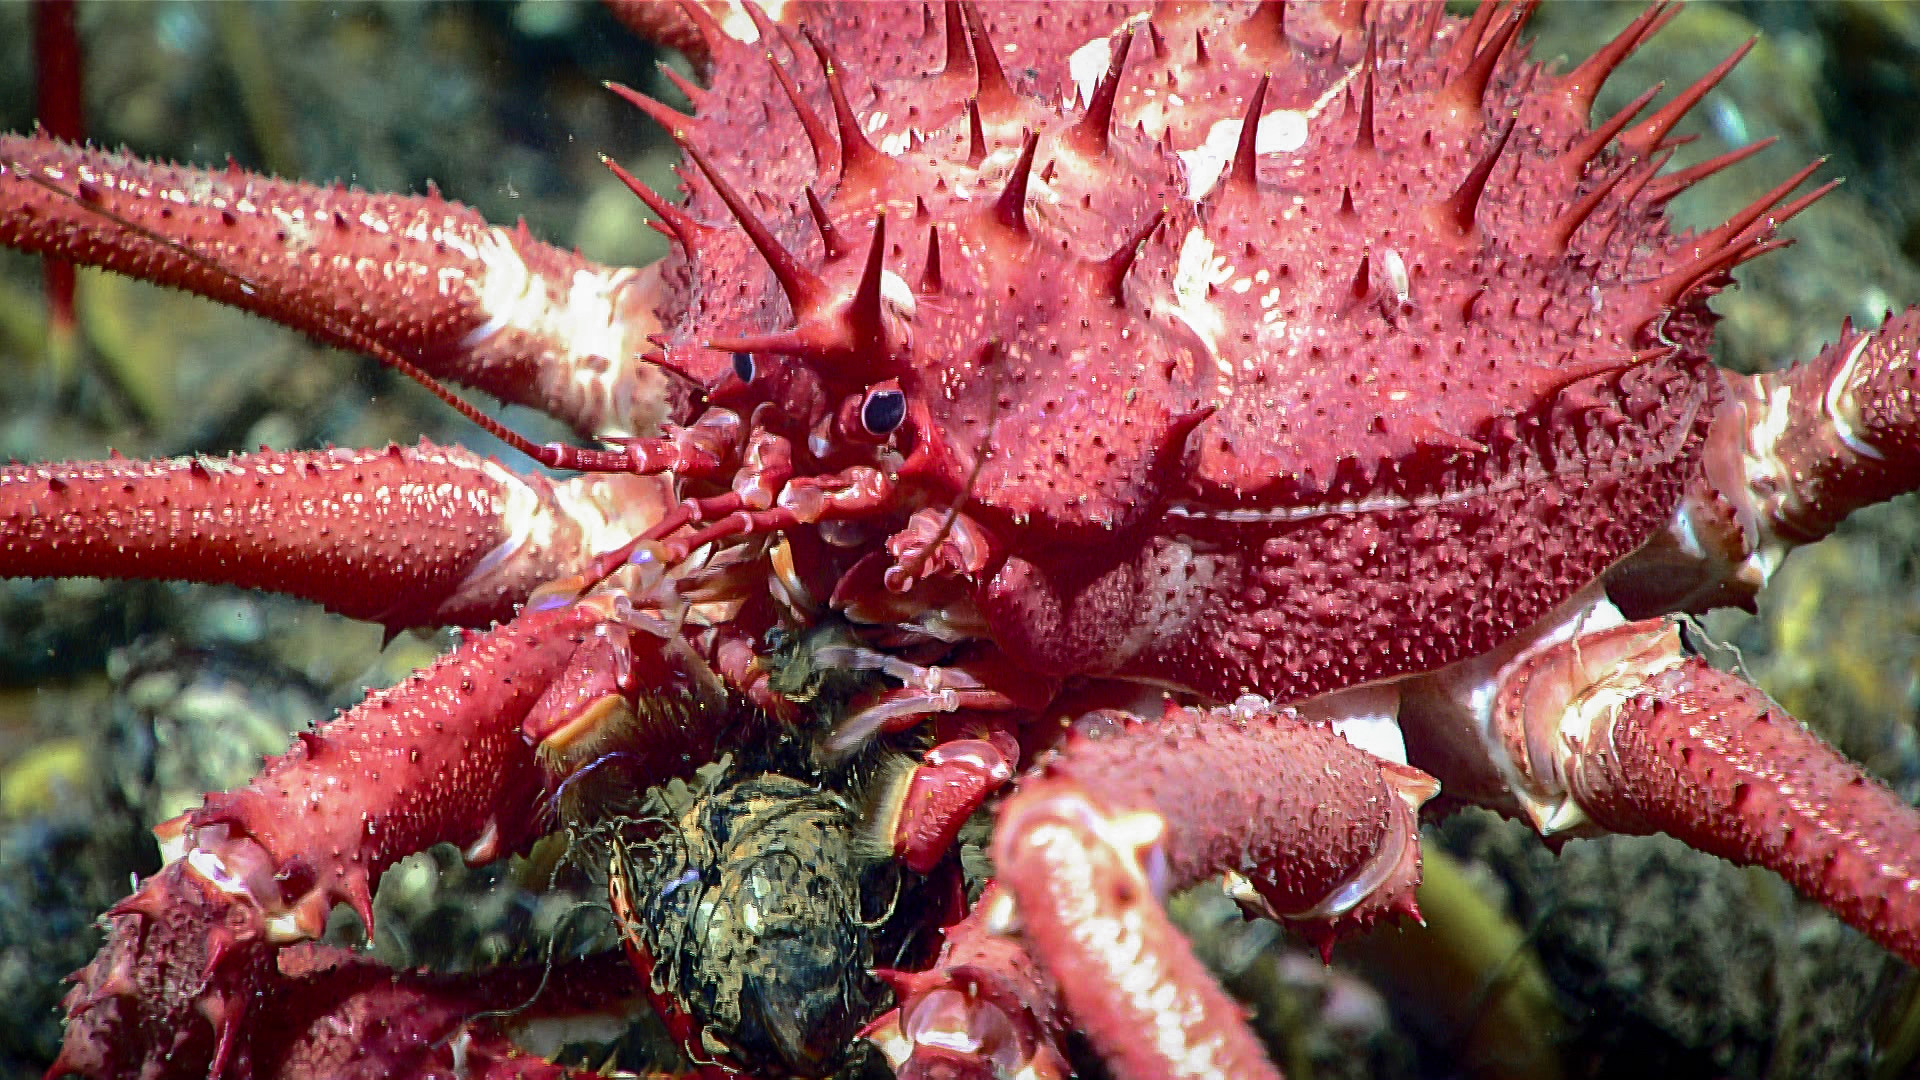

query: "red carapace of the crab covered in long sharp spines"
xmin=641 ymin=4 xmax=1766 ymax=714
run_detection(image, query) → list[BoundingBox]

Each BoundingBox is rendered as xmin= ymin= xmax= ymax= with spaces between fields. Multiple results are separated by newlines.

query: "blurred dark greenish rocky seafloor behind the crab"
xmin=0 ymin=0 xmax=1920 ymax=1080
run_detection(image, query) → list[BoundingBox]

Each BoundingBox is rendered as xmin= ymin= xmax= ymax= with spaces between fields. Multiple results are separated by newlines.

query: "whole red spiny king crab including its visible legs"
xmin=0 ymin=2 xmax=1920 ymax=1076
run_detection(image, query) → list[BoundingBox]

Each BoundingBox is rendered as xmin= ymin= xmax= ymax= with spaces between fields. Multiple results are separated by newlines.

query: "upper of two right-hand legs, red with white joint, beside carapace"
xmin=1609 ymin=307 xmax=1920 ymax=615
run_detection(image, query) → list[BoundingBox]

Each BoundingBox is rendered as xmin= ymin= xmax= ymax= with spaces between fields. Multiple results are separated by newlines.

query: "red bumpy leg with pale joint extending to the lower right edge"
xmin=1490 ymin=619 xmax=1920 ymax=965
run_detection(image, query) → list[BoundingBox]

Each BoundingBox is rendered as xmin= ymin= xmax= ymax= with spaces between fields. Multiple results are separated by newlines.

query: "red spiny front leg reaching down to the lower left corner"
xmin=61 ymin=603 xmax=609 ymax=1076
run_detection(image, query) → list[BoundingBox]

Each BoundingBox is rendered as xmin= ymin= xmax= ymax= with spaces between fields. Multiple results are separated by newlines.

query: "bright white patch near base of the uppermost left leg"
xmin=456 ymin=229 xmax=639 ymax=434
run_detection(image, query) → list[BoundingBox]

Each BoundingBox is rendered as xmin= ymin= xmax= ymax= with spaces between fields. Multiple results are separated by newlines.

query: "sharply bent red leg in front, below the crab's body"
xmin=993 ymin=700 xmax=1436 ymax=1080
